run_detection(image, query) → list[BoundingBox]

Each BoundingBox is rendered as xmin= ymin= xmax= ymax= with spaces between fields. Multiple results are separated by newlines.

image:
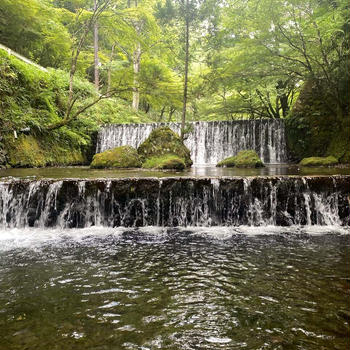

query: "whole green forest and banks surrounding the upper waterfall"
xmin=0 ymin=0 xmax=350 ymax=166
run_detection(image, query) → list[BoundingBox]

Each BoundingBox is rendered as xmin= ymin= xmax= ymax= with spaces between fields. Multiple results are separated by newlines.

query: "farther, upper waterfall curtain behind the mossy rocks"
xmin=96 ymin=119 xmax=287 ymax=164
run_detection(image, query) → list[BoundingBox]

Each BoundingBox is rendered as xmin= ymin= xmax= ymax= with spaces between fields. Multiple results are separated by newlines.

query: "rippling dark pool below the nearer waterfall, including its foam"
xmin=0 ymin=227 xmax=350 ymax=350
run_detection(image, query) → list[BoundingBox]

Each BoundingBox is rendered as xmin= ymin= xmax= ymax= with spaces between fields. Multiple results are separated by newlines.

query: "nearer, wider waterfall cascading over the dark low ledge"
xmin=0 ymin=175 xmax=350 ymax=228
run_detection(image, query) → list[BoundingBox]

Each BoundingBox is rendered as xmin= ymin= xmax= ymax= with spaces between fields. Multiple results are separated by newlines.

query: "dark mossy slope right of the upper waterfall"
xmin=286 ymin=80 xmax=350 ymax=163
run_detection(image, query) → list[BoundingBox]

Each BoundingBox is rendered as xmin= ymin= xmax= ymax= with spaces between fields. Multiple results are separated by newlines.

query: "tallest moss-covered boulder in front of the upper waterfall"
xmin=137 ymin=127 xmax=192 ymax=167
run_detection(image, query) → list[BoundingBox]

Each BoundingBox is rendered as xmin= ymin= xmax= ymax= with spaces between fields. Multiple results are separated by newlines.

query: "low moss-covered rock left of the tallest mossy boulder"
xmin=90 ymin=146 xmax=141 ymax=168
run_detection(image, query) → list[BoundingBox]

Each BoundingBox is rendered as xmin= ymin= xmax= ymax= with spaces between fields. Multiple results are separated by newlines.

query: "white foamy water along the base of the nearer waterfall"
xmin=0 ymin=226 xmax=350 ymax=252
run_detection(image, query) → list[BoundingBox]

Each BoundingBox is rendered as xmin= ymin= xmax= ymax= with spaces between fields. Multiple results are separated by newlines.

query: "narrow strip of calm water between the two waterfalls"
xmin=0 ymin=164 xmax=350 ymax=178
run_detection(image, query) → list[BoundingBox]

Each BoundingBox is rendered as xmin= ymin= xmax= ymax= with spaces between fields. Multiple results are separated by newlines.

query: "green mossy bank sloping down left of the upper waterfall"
xmin=0 ymin=49 xmax=152 ymax=167
